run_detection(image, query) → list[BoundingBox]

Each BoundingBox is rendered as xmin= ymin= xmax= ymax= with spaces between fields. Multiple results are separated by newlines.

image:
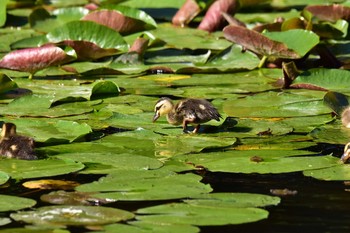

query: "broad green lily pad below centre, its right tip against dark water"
xmin=76 ymin=169 xmax=212 ymax=201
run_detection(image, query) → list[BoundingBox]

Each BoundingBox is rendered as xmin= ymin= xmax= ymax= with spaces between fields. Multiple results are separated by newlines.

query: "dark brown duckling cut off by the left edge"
xmin=0 ymin=123 xmax=37 ymax=160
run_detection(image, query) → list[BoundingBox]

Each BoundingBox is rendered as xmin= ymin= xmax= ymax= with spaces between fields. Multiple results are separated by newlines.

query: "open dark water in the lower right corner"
xmin=201 ymin=171 xmax=350 ymax=233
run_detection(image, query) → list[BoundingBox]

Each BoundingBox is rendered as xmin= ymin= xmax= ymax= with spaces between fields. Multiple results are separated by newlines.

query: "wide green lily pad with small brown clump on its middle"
xmin=174 ymin=150 xmax=339 ymax=174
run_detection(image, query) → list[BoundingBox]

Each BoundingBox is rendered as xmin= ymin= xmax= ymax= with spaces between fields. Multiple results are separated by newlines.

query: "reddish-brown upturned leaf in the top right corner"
xmin=305 ymin=4 xmax=350 ymax=22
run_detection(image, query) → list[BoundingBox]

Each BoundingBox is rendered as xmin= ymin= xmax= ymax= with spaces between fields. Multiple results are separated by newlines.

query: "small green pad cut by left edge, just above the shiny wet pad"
xmin=0 ymin=195 xmax=36 ymax=212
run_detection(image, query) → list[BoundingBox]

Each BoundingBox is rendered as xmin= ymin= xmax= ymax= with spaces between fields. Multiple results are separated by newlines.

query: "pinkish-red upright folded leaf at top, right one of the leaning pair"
xmin=198 ymin=0 xmax=239 ymax=32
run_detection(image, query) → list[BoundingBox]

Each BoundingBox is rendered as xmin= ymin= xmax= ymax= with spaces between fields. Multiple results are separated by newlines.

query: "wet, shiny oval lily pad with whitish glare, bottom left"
xmin=11 ymin=206 xmax=134 ymax=226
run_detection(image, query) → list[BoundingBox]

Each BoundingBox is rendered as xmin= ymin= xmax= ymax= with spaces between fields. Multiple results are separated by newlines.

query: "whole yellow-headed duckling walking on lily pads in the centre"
xmin=153 ymin=97 xmax=221 ymax=133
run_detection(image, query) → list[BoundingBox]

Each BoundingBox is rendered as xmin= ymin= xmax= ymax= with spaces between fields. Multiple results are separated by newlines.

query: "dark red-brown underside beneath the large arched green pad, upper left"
xmin=62 ymin=40 xmax=118 ymax=60
